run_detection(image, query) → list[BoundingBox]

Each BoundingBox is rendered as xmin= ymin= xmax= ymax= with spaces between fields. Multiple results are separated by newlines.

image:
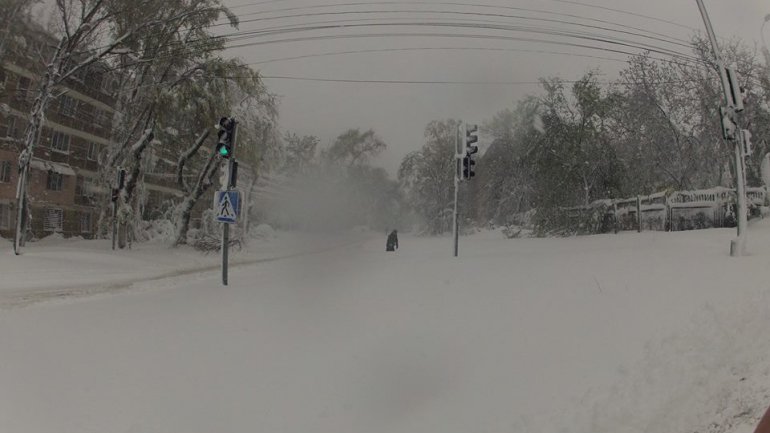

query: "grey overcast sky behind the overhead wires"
xmin=219 ymin=0 xmax=770 ymax=176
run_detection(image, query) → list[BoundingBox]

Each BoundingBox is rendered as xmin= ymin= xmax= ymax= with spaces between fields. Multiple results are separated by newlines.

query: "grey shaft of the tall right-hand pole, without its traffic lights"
xmin=695 ymin=0 xmax=748 ymax=256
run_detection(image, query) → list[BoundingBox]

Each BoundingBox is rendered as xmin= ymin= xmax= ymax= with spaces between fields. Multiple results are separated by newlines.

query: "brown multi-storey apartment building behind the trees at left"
xmin=0 ymin=25 xmax=181 ymax=238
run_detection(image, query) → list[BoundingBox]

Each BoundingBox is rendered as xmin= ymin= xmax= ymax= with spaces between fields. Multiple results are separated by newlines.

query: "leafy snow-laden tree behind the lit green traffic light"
xmin=94 ymin=0 xmax=248 ymax=245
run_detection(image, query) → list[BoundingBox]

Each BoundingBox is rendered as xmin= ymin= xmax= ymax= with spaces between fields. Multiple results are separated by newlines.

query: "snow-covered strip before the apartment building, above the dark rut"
xmin=0 ymin=232 xmax=367 ymax=307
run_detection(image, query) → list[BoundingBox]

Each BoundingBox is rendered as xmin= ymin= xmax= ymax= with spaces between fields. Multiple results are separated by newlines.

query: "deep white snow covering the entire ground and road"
xmin=0 ymin=221 xmax=770 ymax=433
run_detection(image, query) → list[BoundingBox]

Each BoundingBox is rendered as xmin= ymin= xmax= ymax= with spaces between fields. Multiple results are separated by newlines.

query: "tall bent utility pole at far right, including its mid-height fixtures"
xmin=696 ymin=0 xmax=748 ymax=256
